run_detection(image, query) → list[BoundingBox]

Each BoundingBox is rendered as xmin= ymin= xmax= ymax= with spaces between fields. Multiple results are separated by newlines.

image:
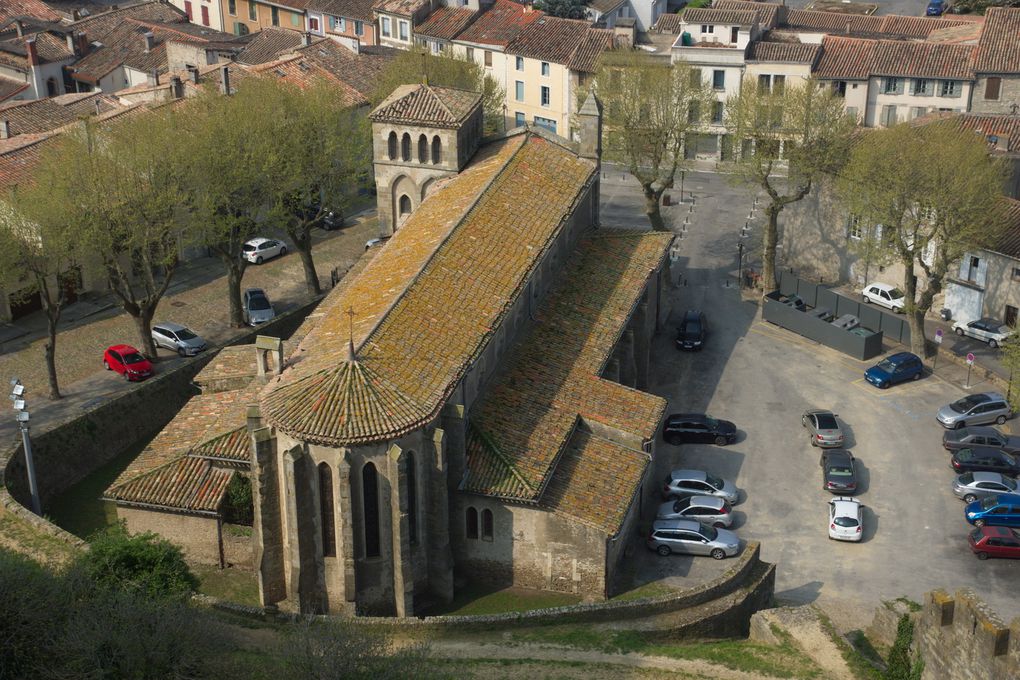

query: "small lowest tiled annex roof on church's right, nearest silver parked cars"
xmin=542 ymin=431 xmax=651 ymax=536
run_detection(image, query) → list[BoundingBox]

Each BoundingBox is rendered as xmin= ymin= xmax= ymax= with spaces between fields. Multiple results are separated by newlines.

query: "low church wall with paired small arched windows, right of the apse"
xmin=451 ymin=493 xmax=606 ymax=599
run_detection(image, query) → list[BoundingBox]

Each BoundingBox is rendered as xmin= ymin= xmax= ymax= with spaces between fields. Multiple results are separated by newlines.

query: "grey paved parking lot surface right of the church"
xmin=620 ymin=170 xmax=1020 ymax=620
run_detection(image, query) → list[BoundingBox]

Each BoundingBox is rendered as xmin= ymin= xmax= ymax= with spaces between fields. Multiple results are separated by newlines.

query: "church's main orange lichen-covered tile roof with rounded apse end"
xmin=262 ymin=132 xmax=595 ymax=446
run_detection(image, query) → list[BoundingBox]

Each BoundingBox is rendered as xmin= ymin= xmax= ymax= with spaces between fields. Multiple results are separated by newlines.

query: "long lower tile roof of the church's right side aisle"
xmin=461 ymin=230 xmax=672 ymax=517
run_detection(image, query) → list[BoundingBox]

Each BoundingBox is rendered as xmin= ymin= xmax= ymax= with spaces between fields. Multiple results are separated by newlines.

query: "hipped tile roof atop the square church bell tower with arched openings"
xmin=369 ymin=85 xmax=481 ymax=127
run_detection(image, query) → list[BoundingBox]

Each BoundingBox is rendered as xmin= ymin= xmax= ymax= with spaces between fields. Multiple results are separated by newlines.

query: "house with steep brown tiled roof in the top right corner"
xmin=970 ymin=7 xmax=1020 ymax=115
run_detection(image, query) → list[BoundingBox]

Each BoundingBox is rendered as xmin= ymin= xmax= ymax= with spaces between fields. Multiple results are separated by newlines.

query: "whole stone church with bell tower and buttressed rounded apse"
xmin=106 ymin=85 xmax=672 ymax=616
